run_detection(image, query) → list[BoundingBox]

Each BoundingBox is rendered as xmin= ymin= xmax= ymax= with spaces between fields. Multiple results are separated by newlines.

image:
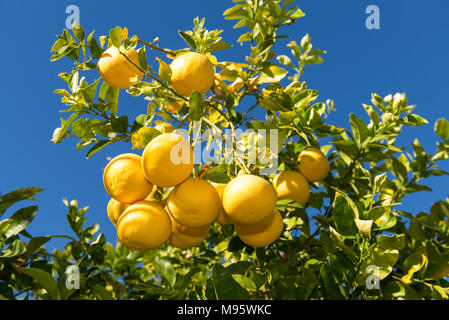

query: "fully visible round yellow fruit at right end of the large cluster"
xmin=222 ymin=174 xmax=277 ymax=223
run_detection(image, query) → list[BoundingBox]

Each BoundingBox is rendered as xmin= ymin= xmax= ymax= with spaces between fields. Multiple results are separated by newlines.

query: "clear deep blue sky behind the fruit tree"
xmin=0 ymin=0 xmax=449 ymax=247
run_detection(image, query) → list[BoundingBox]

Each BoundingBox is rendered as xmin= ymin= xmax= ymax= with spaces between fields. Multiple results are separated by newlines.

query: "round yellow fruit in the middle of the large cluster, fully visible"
xmin=167 ymin=178 xmax=221 ymax=228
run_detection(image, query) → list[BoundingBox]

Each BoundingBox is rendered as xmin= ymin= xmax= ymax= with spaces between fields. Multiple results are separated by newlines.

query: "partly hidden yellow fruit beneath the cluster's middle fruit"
xmin=168 ymin=218 xmax=210 ymax=249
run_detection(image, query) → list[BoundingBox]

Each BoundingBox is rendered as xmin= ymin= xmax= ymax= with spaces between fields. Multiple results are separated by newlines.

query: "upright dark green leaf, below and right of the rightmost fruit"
xmin=333 ymin=193 xmax=358 ymax=238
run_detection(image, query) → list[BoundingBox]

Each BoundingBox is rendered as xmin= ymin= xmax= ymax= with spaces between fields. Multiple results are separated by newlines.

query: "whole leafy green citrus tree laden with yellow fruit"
xmin=0 ymin=0 xmax=449 ymax=299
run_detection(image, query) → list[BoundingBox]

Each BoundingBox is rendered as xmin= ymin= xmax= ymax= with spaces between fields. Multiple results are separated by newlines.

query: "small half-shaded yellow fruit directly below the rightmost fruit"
xmin=273 ymin=170 xmax=310 ymax=206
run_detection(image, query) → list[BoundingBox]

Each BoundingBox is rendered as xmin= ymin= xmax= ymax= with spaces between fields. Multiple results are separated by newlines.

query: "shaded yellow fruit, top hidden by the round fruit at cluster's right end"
xmin=234 ymin=209 xmax=284 ymax=248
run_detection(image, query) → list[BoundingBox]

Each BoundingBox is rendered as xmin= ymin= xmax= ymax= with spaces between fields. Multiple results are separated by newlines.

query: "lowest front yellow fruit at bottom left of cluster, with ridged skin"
xmin=117 ymin=200 xmax=172 ymax=251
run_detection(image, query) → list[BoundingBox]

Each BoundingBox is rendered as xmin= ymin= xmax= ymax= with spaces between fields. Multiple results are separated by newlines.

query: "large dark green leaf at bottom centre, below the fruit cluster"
xmin=212 ymin=263 xmax=249 ymax=300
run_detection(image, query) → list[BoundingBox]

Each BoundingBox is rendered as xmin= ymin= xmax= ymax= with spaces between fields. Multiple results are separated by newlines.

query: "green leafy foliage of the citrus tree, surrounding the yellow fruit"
xmin=0 ymin=0 xmax=449 ymax=299
